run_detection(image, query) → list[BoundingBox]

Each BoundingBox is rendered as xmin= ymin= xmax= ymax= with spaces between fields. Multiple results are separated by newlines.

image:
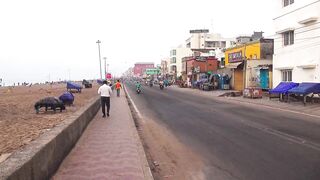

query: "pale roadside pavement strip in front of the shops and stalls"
xmin=170 ymin=87 xmax=320 ymax=116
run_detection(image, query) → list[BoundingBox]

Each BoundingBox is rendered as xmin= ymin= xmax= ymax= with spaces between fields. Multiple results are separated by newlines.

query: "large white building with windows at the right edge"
xmin=273 ymin=0 xmax=320 ymax=87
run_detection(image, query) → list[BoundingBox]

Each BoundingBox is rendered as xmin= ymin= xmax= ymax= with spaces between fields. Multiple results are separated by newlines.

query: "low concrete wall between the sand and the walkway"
xmin=0 ymin=97 xmax=100 ymax=180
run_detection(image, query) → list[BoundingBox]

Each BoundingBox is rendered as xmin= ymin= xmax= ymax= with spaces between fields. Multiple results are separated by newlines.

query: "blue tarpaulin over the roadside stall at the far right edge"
xmin=288 ymin=82 xmax=320 ymax=95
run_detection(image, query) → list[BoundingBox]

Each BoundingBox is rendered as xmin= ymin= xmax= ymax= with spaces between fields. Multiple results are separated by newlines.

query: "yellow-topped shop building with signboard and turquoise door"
xmin=225 ymin=38 xmax=273 ymax=91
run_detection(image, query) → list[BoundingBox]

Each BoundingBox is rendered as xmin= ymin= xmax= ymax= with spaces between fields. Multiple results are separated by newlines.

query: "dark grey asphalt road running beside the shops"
xmin=127 ymin=84 xmax=320 ymax=180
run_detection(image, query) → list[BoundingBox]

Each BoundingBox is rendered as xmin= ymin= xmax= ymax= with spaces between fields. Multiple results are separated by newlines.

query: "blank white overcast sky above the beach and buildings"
xmin=0 ymin=0 xmax=277 ymax=85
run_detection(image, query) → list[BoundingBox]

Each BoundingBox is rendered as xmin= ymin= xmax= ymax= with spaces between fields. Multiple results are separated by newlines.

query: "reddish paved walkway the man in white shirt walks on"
xmin=52 ymin=91 xmax=152 ymax=180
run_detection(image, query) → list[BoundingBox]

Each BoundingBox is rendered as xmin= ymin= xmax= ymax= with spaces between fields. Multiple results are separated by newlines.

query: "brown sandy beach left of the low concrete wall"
xmin=0 ymin=83 xmax=99 ymax=162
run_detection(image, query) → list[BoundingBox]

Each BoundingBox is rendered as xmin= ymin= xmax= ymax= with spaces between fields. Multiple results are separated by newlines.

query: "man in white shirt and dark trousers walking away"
xmin=98 ymin=81 xmax=112 ymax=117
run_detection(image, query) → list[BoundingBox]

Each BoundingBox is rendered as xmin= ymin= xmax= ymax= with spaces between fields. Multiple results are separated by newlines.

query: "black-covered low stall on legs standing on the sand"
xmin=34 ymin=97 xmax=66 ymax=114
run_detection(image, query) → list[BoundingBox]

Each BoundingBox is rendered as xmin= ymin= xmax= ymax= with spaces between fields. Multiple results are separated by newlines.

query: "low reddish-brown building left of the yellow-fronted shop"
xmin=182 ymin=56 xmax=218 ymax=86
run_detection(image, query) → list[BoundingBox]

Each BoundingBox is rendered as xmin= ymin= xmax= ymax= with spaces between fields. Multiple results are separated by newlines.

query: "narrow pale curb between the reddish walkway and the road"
xmin=123 ymin=85 xmax=154 ymax=180
